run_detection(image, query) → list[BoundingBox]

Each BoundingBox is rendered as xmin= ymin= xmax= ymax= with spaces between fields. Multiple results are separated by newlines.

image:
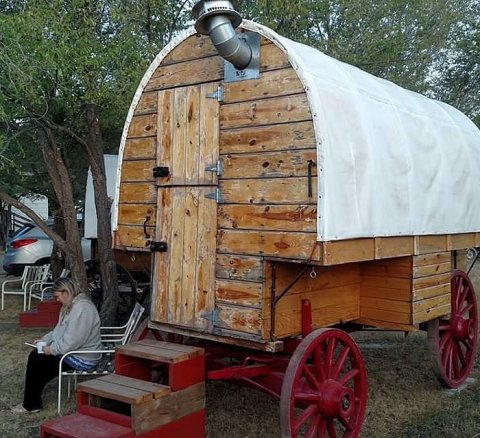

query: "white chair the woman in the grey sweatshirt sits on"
xmin=57 ymin=303 xmax=145 ymax=414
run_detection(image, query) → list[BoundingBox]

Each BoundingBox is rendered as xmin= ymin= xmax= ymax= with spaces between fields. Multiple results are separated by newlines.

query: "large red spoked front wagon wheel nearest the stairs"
xmin=280 ymin=329 xmax=367 ymax=438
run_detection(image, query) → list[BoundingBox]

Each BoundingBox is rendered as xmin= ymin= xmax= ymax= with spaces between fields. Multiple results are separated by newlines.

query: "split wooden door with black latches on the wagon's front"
xmin=152 ymin=84 xmax=219 ymax=331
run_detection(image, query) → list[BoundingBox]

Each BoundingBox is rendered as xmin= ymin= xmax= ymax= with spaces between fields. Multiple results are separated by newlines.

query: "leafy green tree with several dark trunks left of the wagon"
xmin=0 ymin=0 xmax=191 ymax=321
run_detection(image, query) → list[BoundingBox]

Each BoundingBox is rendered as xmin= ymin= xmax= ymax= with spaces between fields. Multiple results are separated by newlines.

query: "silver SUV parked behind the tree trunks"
xmin=3 ymin=220 xmax=91 ymax=276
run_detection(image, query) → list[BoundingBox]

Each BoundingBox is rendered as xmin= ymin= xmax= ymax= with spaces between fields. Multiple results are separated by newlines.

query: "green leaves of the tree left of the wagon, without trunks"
xmin=0 ymin=0 xmax=191 ymax=204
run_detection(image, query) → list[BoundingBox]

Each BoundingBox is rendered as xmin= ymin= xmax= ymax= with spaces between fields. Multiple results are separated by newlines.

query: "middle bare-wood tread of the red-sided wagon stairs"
xmin=78 ymin=374 xmax=170 ymax=405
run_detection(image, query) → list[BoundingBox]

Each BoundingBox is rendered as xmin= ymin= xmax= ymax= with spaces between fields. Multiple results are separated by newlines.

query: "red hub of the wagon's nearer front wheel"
xmin=318 ymin=379 xmax=355 ymax=418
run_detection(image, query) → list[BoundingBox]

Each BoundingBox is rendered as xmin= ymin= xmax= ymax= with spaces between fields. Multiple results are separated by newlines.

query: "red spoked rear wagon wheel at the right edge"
xmin=428 ymin=270 xmax=478 ymax=388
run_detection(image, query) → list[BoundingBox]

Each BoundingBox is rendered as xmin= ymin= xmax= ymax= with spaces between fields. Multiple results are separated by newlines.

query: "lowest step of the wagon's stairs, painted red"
xmin=40 ymin=412 xmax=135 ymax=438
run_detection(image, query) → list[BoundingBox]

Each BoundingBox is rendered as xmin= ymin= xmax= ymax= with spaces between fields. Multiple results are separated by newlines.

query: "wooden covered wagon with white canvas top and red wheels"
xmin=110 ymin=1 xmax=480 ymax=436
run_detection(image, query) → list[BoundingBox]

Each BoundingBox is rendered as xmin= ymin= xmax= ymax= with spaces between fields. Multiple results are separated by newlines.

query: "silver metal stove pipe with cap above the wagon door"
xmin=192 ymin=0 xmax=252 ymax=70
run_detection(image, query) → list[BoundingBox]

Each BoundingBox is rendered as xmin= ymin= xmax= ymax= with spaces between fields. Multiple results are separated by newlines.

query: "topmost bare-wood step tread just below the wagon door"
xmin=117 ymin=339 xmax=204 ymax=363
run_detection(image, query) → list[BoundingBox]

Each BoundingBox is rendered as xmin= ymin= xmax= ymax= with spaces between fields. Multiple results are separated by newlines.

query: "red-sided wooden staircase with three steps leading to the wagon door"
xmin=40 ymin=339 xmax=205 ymax=438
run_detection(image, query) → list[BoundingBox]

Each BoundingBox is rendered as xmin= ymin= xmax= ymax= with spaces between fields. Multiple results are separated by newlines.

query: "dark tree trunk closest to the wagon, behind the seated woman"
xmin=86 ymin=104 xmax=118 ymax=325
